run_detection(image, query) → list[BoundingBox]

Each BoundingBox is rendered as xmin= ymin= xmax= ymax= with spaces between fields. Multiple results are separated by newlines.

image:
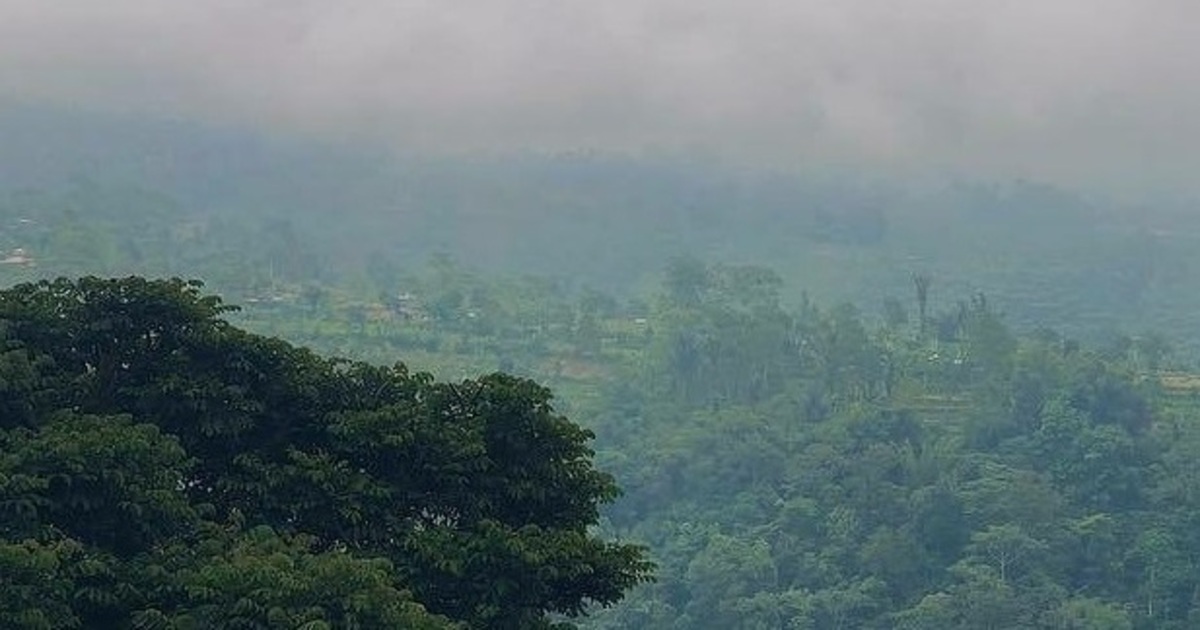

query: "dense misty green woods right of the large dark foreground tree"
xmin=576 ymin=262 xmax=1200 ymax=630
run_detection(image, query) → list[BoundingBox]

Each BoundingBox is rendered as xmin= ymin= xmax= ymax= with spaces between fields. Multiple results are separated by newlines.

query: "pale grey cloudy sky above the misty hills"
xmin=0 ymin=0 xmax=1200 ymax=186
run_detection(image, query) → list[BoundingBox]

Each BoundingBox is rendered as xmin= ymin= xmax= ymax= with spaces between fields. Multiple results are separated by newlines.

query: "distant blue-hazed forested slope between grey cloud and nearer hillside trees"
xmin=7 ymin=115 xmax=1200 ymax=355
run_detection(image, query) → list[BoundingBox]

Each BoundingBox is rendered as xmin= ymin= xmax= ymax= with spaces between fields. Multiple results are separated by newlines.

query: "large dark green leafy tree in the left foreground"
xmin=0 ymin=277 xmax=650 ymax=629
